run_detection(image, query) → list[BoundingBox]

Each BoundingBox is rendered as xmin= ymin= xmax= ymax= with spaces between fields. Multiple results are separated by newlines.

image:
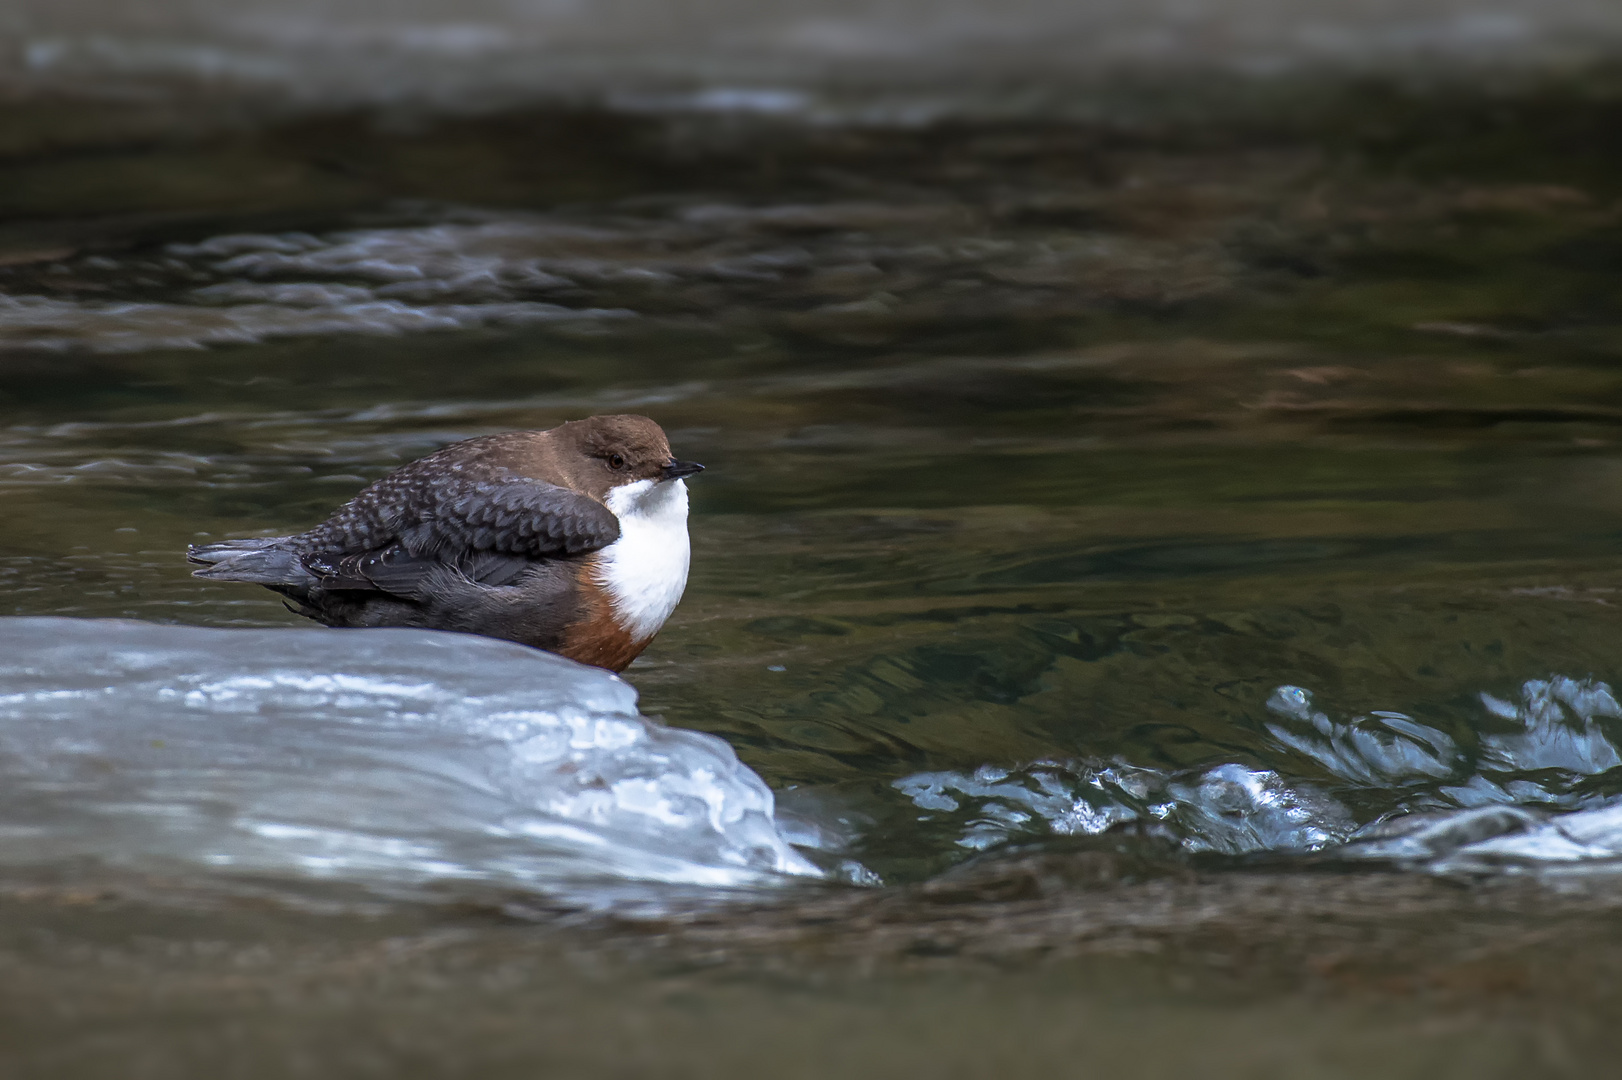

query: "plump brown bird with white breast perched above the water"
xmin=187 ymin=415 xmax=704 ymax=671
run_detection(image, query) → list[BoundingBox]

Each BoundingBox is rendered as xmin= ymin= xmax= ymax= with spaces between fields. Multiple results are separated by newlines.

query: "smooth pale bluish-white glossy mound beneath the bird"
xmin=0 ymin=618 xmax=819 ymax=906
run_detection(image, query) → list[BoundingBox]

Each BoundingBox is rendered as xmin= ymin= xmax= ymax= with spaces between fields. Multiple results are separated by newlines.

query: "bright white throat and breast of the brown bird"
xmin=597 ymin=480 xmax=693 ymax=641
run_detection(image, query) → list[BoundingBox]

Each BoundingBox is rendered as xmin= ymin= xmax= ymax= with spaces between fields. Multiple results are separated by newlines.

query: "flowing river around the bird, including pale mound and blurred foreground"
xmin=0 ymin=56 xmax=1622 ymax=1077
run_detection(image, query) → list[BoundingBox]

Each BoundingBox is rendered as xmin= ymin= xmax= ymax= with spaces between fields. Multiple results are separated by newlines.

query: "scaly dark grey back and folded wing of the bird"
xmin=300 ymin=467 xmax=620 ymax=597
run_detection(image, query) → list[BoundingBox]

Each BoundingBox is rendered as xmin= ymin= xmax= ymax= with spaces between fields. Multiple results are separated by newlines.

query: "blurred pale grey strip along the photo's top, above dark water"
xmin=9 ymin=0 xmax=1622 ymax=100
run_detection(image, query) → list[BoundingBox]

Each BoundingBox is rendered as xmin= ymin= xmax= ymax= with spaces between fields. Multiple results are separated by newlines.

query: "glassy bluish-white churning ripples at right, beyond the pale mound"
xmin=894 ymin=676 xmax=1622 ymax=874
